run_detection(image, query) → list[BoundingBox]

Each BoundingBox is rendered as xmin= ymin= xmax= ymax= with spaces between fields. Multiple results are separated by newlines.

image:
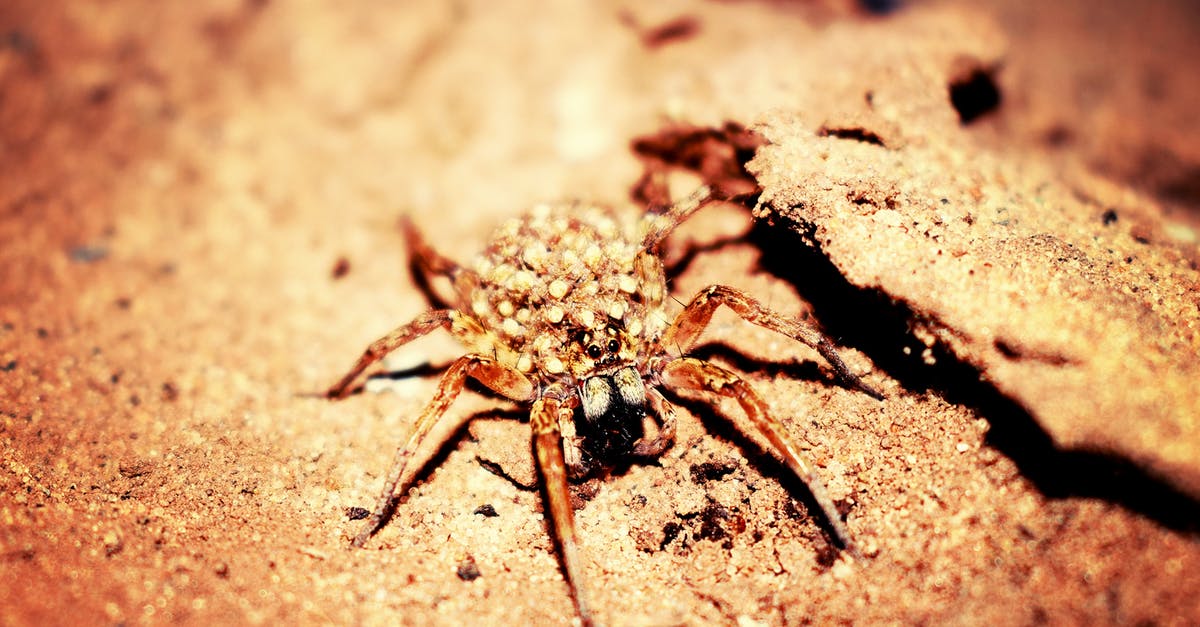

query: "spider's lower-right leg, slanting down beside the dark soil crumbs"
xmin=659 ymin=357 xmax=858 ymax=556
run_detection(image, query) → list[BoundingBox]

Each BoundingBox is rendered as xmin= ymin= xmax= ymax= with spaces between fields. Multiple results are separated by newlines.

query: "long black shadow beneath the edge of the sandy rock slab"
xmin=750 ymin=217 xmax=1200 ymax=535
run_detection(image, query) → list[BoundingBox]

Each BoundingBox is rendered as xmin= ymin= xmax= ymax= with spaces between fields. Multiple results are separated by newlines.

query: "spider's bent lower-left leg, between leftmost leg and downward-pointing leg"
xmin=353 ymin=354 xmax=534 ymax=547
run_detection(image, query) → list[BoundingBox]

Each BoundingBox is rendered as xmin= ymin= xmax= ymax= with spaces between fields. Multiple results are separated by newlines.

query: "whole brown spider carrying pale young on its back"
xmin=326 ymin=187 xmax=882 ymax=625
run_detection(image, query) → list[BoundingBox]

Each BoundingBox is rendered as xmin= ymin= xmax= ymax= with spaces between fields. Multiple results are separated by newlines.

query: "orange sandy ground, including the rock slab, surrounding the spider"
xmin=0 ymin=0 xmax=1200 ymax=626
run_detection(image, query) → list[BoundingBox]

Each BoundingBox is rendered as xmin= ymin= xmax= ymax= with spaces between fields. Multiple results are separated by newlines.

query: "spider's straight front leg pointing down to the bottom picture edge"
xmin=529 ymin=396 xmax=593 ymax=626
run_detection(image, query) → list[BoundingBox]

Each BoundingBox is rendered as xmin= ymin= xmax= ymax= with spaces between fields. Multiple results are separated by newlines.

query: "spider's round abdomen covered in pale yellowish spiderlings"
xmin=460 ymin=204 xmax=665 ymax=380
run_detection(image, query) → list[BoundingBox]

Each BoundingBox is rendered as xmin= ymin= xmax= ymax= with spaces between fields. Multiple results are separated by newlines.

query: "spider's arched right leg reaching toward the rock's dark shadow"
xmin=660 ymin=285 xmax=883 ymax=400
